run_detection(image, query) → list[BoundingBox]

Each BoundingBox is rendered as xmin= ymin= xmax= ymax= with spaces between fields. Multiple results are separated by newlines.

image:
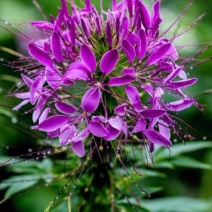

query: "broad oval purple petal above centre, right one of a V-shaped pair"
xmin=100 ymin=49 xmax=119 ymax=74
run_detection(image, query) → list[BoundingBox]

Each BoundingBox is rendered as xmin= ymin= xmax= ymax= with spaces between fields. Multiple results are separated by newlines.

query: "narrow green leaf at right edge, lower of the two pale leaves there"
xmin=171 ymin=157 xmax=211 ymax=169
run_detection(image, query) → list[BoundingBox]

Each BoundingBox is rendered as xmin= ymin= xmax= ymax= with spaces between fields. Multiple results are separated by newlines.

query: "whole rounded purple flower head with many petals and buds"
xmin=14 ymin=0 xmax=197 ymax=157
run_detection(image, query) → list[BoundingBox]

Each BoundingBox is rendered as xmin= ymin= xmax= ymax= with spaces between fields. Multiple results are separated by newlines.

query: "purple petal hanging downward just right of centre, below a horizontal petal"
xmin=126 ymin=85 xmax=141 ymax=112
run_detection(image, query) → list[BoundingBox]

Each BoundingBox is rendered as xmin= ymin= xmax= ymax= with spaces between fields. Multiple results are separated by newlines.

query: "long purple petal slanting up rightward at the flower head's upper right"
xmin=147 ymin=43 xmax=171 ymax=65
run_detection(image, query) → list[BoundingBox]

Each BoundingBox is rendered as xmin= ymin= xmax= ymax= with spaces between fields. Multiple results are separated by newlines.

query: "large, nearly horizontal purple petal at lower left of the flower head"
xmin=38 ymin=115 xmax=69 ymax=132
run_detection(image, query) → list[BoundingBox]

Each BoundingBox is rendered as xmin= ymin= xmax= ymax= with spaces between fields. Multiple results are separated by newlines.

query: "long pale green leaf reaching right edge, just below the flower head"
xmin=154 ymin=141 xmax=212 ymax=162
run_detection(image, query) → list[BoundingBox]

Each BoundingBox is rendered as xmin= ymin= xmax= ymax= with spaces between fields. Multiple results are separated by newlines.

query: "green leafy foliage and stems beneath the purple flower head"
xmin=0 ymin=141 xmax=212 ymax=212
